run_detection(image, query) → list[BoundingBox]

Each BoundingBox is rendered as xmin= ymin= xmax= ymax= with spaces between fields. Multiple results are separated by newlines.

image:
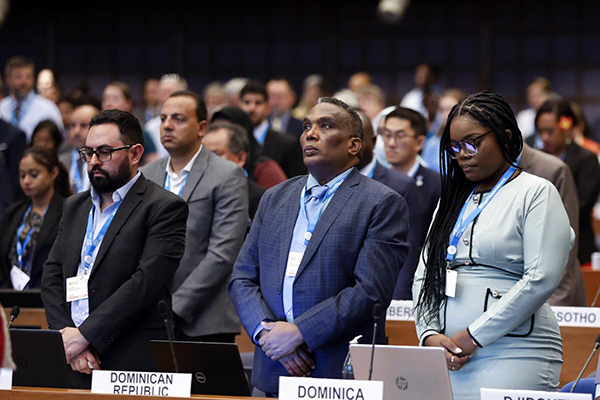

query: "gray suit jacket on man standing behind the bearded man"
xmin=142 ymin=147 xmax=248 ymax=336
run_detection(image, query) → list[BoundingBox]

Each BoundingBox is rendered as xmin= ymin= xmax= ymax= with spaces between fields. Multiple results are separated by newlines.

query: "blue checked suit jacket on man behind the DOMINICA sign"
xmin=229 ymin=169 xmax=408 ymax=393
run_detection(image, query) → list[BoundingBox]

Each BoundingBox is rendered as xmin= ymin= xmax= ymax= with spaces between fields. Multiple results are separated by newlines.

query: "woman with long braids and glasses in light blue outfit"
xmin=413 ymin=92 xmax=574 ymax=400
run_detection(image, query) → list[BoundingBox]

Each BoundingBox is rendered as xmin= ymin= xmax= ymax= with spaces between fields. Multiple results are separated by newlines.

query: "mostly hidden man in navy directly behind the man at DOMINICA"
xmin=356 ymin=112 xmax=428 ymax=300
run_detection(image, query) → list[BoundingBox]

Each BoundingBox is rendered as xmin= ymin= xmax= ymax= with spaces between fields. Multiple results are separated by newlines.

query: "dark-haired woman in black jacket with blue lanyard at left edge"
xmin=0 ymin=147 xmax=70 ymax=290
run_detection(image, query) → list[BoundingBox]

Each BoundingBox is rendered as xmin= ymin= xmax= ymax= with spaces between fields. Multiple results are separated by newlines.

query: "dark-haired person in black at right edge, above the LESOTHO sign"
xmin=535 ymin=99 xmax=600 ymax=264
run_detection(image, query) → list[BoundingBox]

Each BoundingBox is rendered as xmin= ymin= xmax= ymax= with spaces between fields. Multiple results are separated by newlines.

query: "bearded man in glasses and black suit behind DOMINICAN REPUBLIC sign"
xmin=42 ymin=110 xmax=188 ymax=374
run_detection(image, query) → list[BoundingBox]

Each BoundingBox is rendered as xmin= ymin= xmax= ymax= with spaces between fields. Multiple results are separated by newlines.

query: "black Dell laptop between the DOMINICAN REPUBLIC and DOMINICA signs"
xmin=150 ymin=340 xmax=251 ymax=396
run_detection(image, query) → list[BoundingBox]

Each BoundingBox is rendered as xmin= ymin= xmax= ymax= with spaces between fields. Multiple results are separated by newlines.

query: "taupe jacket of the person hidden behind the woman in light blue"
xmin=519 ymin=143 xmax=586 ymax=306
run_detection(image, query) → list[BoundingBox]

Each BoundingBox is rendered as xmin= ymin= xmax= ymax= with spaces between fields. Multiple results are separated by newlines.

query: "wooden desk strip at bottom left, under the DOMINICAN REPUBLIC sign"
xmin=0 ymin=387 xmax=260 ymax=400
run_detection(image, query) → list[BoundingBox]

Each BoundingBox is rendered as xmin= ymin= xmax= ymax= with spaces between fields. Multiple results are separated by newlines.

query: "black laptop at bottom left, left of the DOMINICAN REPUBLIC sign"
xmin=10 ymin=329 xmax=91 ymax=389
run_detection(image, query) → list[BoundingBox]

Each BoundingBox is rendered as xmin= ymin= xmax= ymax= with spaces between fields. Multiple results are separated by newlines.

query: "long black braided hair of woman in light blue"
xmin=415 ymin=91 xmax=523 ymax=323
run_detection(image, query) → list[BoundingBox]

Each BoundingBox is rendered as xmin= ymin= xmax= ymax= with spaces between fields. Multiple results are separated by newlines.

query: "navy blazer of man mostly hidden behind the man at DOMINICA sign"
xmin=373 ymin=163 xmax=429 ymax=300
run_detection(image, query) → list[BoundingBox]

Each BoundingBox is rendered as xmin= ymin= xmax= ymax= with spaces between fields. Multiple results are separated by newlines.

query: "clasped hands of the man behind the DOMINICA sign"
xmin=258 ymin=321 xmax=315 ymax=376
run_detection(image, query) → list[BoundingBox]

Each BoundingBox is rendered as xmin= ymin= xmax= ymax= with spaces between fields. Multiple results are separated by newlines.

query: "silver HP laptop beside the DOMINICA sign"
xmin=350 ymin=344 xmax=452 ymax=400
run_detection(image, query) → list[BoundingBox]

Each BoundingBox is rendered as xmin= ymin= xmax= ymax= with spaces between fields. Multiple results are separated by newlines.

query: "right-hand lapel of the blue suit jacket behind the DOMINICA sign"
xmin=290 ymin=168 xmax=361 ymax=276
